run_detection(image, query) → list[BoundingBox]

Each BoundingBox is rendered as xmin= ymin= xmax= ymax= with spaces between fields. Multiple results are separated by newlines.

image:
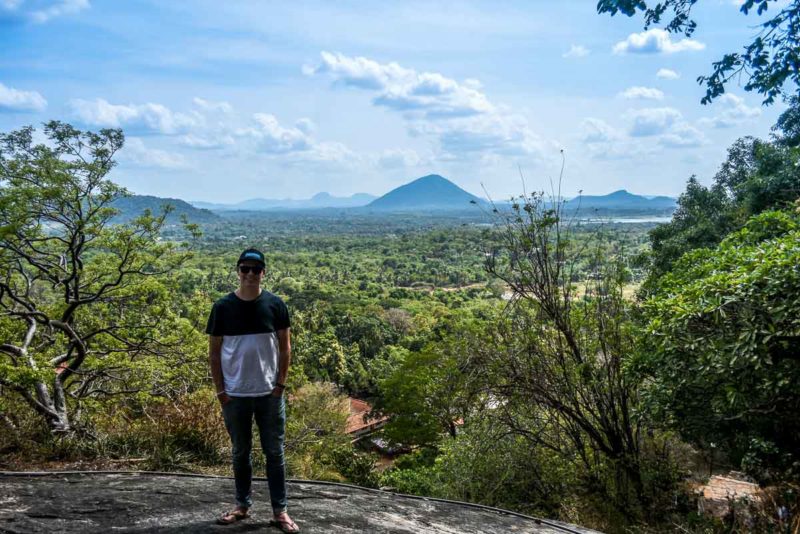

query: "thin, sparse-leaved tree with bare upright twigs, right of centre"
xmin=482 ymin=194 xmax=646 ymax=518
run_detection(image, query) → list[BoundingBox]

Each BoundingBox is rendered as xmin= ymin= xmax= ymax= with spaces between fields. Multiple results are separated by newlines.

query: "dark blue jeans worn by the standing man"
xmin=222 ymin=395 xmax=286 ymax=514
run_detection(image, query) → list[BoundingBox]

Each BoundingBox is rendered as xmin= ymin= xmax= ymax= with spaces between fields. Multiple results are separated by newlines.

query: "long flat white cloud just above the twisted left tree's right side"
xmin=70 ymin=98 xmax=203 ymax=135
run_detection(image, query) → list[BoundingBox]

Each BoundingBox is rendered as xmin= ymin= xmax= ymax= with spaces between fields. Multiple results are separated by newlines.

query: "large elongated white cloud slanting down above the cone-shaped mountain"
xmin=304 ymin=52 xmax=494 ymax=119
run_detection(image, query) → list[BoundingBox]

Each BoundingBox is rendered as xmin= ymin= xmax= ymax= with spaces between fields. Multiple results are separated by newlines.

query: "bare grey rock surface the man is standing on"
xmin=0 ymin=473 xmax=593 ymax=534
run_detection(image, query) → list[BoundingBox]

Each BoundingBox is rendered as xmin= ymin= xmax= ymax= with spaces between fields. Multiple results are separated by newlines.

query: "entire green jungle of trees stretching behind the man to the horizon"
xmin=0 ymin=97 xmax=800 ymax=532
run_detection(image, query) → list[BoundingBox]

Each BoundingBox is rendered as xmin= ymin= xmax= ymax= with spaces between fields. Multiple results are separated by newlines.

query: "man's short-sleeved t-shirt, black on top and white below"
xmin=206 ymin=291 xmax=289 ymax=397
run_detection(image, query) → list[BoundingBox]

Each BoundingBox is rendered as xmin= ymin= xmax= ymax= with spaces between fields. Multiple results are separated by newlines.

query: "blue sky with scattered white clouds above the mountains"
xmin=0 ymin=0 xmax=785 ymax=203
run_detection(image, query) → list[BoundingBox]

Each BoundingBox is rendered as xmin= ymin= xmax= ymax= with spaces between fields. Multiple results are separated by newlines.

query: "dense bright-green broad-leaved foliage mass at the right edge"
xmin=636 ymin=211 xmax=800 ymax=481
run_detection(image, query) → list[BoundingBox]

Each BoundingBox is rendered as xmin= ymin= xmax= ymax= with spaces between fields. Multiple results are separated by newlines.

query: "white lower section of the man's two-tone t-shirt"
xmin=222 ymin=332 xmax=280 ymax=397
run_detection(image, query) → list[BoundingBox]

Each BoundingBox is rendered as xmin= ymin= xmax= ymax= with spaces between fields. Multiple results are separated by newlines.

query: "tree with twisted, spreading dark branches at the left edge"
xmin=0 ymin=121 xmax=202 ymax=431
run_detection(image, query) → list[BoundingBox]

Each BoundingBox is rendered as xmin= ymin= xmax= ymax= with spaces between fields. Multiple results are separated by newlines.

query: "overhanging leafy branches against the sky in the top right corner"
xmin=597 ymin=0 xmax=800 ymax=104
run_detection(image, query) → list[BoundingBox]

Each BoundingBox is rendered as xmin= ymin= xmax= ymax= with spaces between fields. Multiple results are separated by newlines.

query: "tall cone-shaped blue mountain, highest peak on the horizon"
xmin=367 ymin=174 xmax=483 ymax=211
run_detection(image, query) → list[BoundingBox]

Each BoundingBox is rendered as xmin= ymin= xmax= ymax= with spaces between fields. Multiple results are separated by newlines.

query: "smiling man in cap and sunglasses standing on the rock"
xmin=206 ymin=248 xmax=300 ymax=533
